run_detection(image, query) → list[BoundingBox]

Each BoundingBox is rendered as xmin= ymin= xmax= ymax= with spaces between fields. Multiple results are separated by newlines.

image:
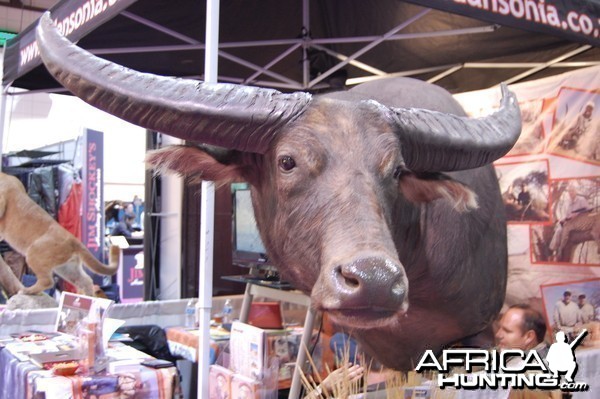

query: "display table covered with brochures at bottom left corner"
xmin=0 ymin=332 xmax=179 ymax=399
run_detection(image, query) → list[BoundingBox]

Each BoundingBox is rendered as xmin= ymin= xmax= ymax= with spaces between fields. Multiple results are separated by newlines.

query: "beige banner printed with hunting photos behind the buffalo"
xmin=455 ymin=67 xmax=600 ymax=321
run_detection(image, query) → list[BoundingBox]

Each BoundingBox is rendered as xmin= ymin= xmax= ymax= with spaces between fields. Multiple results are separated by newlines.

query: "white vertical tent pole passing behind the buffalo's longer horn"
xmin=198 ymin=0 xmax=220 ymax=398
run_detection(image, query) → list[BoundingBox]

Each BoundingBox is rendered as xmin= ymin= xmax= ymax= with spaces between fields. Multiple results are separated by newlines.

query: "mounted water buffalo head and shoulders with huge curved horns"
xmin=37 ymin=15 xmax=521 ymax=370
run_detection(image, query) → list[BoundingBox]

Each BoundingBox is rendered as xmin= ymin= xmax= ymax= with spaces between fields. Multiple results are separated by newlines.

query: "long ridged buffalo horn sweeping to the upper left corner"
xmin=36 ymin=13 xmax=311 ymax=153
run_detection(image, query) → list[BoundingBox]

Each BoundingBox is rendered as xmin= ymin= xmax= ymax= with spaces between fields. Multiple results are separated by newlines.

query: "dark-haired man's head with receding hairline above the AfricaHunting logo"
xmin=496 ymin=305 xmax=546 ymax=350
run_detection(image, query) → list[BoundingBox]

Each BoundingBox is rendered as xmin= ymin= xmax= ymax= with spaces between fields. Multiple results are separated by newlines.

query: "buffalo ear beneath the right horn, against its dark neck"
xmin=399 ymin=172 xmax=478 ymax=212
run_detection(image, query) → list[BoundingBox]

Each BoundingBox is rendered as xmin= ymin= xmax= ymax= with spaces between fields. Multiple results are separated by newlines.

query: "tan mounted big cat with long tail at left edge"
xmin=0 ymin=172 xmax=119 ymax=296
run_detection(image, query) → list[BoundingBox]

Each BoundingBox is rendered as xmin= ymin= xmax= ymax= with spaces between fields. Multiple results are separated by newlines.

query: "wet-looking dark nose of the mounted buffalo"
xmin=333 ymin=257 xmax=408 ymax=310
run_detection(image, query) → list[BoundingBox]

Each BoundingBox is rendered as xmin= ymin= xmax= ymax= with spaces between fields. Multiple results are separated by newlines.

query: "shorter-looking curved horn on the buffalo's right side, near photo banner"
xmin=392 ymin=84 xmax=521 ymax=172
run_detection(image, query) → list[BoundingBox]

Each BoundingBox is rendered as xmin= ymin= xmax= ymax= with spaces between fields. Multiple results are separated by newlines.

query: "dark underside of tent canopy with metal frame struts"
xmin=5 ymin=0 xmax=600 ymax=93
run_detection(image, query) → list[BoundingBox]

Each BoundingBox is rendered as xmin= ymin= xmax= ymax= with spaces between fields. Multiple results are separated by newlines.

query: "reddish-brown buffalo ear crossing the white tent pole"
xmin=146 ymin=145 xmax=244 ymax=184
